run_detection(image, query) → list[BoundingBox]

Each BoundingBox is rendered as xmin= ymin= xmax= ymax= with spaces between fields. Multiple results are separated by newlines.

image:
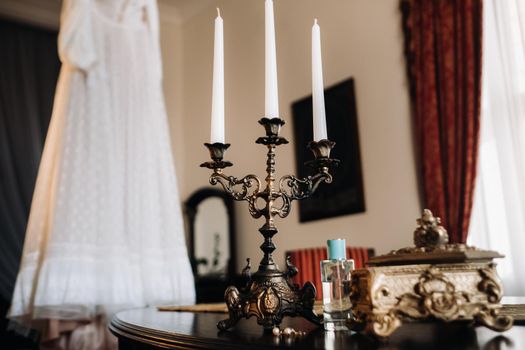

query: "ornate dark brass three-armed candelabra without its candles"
xmin=201 ymin=118 xmax=339 ymax=330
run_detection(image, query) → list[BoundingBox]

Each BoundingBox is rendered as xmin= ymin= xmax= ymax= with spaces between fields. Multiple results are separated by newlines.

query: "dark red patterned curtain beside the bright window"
xmin=401 ymin=0 xmax=482 ymax=243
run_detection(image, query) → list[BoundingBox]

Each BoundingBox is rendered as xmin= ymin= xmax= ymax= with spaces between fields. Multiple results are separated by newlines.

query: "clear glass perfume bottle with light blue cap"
xmin=321 ymin=239 xmax=354 ymax=331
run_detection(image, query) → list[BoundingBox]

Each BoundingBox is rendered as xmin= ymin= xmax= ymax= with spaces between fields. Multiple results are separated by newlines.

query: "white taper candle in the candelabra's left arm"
xmin=210 ymin=8 xmax=224 ymax=143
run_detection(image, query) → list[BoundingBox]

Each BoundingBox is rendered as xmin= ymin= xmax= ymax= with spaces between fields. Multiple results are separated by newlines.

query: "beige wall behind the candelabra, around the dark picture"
xmin=163 ymin=0 xmax=420 ymax=268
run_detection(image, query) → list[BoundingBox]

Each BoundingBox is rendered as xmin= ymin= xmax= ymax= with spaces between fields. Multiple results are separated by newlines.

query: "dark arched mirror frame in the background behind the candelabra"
xmin=184 ymin=187 xmax=236 ymax=279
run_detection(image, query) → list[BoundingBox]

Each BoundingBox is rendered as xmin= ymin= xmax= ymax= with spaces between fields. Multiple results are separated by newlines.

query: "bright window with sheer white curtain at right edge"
xmin=468 ymin=0 xmax=525 ymax=296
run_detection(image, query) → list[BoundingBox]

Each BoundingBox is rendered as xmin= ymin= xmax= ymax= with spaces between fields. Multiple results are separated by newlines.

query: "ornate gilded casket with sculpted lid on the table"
xmin=349 ymin=209 xmax=513 ymax=337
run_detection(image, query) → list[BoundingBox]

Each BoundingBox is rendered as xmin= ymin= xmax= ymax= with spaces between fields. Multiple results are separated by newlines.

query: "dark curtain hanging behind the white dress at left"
xmin=0 ymin=20 xmax=60 ymax=344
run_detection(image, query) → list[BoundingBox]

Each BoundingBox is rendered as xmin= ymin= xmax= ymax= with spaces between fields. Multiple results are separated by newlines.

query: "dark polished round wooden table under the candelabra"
xmin=110 ymin=308 xmax=525 ymax=350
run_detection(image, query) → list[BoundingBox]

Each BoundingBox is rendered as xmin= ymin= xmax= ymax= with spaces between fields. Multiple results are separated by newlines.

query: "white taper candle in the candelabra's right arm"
xmin=312 ymin=18 xmax=328 ymax=141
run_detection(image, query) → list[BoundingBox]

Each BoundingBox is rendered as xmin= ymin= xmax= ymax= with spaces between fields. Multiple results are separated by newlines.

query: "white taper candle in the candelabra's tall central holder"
xmin=264 ymin=0 xmax=279 ymax=118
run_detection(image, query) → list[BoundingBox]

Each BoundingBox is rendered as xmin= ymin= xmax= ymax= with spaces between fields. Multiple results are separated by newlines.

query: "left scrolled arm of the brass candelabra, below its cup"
xmin=210 ymin=171 xmax=261 ymax=202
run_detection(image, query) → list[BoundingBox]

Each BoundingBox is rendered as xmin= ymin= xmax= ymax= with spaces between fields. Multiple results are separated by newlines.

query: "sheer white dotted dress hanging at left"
xmin=10 ymin=0 xmax=195 ymax=340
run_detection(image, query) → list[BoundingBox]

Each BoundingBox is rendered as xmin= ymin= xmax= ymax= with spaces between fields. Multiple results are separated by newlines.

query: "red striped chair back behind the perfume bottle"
xmin=285 ymin=247 xmax=374 ymax=300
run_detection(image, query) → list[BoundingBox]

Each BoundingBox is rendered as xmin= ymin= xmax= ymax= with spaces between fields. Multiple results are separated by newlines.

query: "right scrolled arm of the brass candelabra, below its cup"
xmin=279 ymin=171 xmax=332 ymax=201
